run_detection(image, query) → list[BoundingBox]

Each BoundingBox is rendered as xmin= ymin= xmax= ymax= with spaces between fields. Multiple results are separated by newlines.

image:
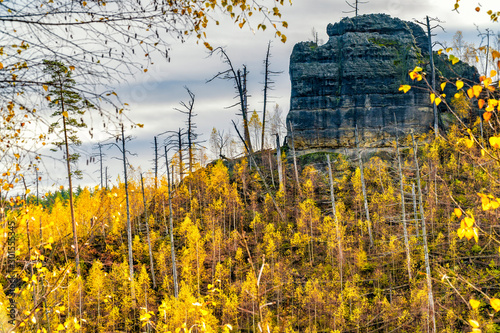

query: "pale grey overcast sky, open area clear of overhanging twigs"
xmin=34 ymin=0 xmax=500 ymax=189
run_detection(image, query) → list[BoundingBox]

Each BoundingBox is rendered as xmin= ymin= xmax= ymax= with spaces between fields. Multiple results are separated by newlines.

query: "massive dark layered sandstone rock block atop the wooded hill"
xmin=287 ymin=14 xmax=475 ymax=149
